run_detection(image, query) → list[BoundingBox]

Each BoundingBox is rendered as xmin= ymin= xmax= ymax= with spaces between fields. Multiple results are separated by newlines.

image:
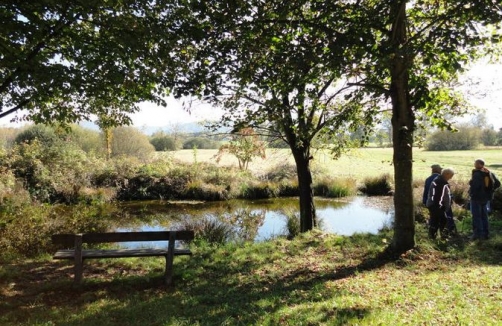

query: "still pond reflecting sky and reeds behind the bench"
xmin=113 ymin=196 xmax=394 ymax=245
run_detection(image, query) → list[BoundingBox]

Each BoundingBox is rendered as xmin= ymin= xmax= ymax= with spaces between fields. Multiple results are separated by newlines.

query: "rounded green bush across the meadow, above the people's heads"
xmin=425 ymin=127 xmax=481 ymax=151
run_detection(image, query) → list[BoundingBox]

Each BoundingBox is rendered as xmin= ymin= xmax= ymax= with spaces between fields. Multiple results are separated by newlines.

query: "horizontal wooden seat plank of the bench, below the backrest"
xmin=53 ymin=248 xmax=192 ymax=259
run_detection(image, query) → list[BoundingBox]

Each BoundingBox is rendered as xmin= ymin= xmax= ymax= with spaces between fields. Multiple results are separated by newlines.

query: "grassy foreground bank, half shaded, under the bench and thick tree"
xmin=0 ymin=225 xmax=502 ymax=326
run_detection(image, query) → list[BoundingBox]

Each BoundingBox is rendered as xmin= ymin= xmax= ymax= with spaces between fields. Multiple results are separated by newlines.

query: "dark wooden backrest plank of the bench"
xmin=52 ymin=230 xmax=194 ymax=247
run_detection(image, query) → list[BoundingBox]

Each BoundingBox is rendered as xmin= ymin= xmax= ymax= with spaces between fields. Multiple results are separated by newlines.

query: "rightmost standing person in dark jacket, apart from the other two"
xmin=469 ymin=159 xmax=500 ymax=240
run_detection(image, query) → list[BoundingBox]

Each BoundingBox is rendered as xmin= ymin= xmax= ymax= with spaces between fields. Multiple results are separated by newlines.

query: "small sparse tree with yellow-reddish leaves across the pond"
xmin=215 ymin=128 xmax=266 ymax=170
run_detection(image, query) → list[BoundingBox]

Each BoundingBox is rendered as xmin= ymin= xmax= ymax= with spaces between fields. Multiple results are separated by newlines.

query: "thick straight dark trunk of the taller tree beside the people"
xmin=390 ymin=1 xmax=415 ymax=252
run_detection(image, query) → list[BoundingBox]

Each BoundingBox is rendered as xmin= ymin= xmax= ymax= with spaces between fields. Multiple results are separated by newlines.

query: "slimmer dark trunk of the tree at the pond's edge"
xmin=291 ymin=146 xmax=317 ymax=232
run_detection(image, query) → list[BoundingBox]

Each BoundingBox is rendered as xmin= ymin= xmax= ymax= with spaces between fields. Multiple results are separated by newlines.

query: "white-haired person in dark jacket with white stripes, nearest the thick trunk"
xmin=426 ymin=168 xmax=455 ymax=239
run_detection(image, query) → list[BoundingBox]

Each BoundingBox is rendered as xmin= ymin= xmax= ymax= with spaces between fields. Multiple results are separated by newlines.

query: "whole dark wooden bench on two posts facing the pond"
xmin=52 ymin=231 xmax=194 ymax=285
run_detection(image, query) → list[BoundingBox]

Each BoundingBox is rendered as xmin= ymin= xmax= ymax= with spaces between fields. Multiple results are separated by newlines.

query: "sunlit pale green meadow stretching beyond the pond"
xmin=168 ymin=148 xmax=502 ymax=180
